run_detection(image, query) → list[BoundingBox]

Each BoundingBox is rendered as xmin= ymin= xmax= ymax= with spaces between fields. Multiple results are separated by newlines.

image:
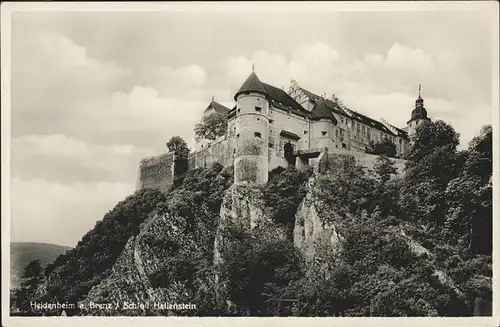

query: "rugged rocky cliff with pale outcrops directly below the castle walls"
xmin=31 ymin=159 xmax=491 ymax=316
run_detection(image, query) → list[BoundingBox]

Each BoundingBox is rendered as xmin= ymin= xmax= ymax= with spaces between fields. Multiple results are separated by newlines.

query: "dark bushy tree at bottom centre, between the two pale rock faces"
xmin=221 ymin=226 xmax=303 ymax=315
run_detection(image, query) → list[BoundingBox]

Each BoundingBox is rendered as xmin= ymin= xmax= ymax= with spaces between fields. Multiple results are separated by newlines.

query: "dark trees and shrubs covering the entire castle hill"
xmin=13 ymin=121 xmax=492 ymax=316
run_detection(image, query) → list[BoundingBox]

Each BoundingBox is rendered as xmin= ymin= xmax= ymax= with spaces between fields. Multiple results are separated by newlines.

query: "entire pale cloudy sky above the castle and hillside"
xmin=4 ymin=4 xmax=497 ymax=246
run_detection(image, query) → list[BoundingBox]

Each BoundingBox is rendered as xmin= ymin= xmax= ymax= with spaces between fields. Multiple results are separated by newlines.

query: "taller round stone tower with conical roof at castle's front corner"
xmin=234 ymin=72 xmax=269 ymax=183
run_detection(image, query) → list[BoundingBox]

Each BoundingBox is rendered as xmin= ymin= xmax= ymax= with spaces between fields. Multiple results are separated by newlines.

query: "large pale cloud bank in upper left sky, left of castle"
xmin=12 ymin=30 xmax=211 ymax=155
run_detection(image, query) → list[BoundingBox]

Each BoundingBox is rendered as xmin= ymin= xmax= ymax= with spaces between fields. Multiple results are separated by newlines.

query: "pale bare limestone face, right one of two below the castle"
xmin=293 ymin=178 xmax=343 ymax=261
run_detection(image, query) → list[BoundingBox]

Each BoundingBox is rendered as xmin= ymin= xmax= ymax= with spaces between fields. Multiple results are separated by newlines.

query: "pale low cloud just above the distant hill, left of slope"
xmin=11 ymin=178 xmax=134 ymax=246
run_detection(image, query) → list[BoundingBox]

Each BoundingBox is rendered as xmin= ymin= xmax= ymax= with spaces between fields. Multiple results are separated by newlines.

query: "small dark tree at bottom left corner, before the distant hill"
xmin=14 ymin=259 xmax=44 ymax=313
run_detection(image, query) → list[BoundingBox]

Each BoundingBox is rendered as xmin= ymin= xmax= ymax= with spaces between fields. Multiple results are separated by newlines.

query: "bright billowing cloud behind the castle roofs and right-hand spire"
xmin=225 ymin=43 xmax=491 ymax=147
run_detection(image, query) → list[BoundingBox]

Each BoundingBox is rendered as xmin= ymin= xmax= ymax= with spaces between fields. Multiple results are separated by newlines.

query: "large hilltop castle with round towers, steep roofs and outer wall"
xmin=137 ymin=71 xmax=430 ymax=188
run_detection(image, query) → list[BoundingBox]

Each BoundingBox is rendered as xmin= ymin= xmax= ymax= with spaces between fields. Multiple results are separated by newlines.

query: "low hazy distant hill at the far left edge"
xmin=10 ymin=242 xmax=71 ymax=289
